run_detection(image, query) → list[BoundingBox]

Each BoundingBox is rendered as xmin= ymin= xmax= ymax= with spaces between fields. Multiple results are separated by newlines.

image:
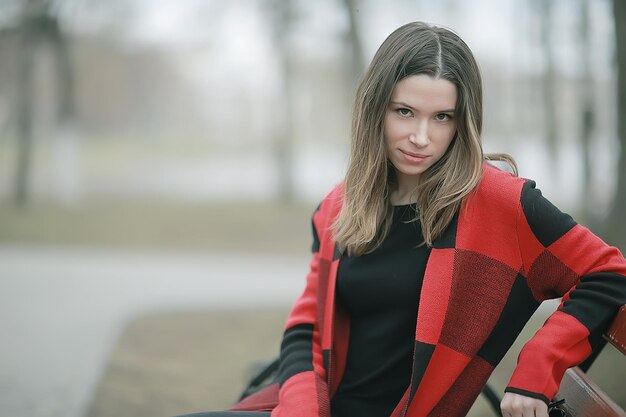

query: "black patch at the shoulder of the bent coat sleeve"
xmin=521 ymin=181 xmax=576 ymax=248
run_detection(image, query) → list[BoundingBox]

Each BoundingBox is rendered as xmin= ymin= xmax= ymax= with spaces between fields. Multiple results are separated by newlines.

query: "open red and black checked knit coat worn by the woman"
xmin=232 ymin=164 xmax=626 ymax=417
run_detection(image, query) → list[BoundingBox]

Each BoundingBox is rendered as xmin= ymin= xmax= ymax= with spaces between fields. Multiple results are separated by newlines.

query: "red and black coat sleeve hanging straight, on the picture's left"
xmin=272 ymin=203 xmax=330 ymax=417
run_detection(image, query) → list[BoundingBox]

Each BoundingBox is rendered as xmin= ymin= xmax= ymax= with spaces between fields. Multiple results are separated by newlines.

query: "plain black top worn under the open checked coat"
xmin=331 ymin=205 xmax=430 ymax=417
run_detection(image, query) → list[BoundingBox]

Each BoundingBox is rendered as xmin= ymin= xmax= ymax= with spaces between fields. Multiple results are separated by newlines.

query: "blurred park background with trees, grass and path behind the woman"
xmin=0 ymin=0 xmax=626 ymax=417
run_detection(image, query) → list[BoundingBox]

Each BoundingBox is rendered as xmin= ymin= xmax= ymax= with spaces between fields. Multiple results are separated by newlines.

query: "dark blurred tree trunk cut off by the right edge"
xmin=605 ymin=0 xmax=626 ymax=251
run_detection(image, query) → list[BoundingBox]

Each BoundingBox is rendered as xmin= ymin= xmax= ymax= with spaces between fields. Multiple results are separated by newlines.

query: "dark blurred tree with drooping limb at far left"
xmin=14 ymin=0 xmax=74 ymax=206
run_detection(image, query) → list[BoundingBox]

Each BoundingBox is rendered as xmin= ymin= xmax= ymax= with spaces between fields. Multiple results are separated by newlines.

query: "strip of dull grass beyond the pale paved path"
xmin=0 ymin=200 xmax=314 ymax=254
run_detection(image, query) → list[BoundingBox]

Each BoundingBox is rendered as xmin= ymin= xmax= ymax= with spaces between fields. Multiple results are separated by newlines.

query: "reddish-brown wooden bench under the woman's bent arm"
xmin=550 ymin=305 xmax=626 ymax=417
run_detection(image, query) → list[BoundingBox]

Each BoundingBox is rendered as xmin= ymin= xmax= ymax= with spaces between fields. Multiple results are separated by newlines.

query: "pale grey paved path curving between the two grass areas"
xmin=0 ymin=246 xmax=308 ymax=417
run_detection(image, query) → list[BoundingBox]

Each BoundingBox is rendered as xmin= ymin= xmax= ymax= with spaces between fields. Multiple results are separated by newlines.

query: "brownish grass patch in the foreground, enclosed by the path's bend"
xmin=85 ymin=309 xmax=287 ymax=417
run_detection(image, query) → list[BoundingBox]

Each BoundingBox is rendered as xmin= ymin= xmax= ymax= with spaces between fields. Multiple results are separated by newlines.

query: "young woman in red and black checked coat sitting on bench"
xmin=177 ymin=22 xmax=626 ymax=417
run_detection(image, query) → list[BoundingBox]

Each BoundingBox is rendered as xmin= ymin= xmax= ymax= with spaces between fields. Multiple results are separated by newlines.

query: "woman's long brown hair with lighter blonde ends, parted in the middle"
xmin=332 ymin=22 xmax=517 ymax=255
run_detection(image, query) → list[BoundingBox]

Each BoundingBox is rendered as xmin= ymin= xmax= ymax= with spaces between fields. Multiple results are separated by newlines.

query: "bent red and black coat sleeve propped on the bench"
xmin=505 ymin=181 xmax=626 ymax=402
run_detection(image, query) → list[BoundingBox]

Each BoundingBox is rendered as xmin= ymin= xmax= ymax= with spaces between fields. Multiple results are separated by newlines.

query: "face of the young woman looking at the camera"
xmin=384 ymin=74 xmax=457 ymax=191
